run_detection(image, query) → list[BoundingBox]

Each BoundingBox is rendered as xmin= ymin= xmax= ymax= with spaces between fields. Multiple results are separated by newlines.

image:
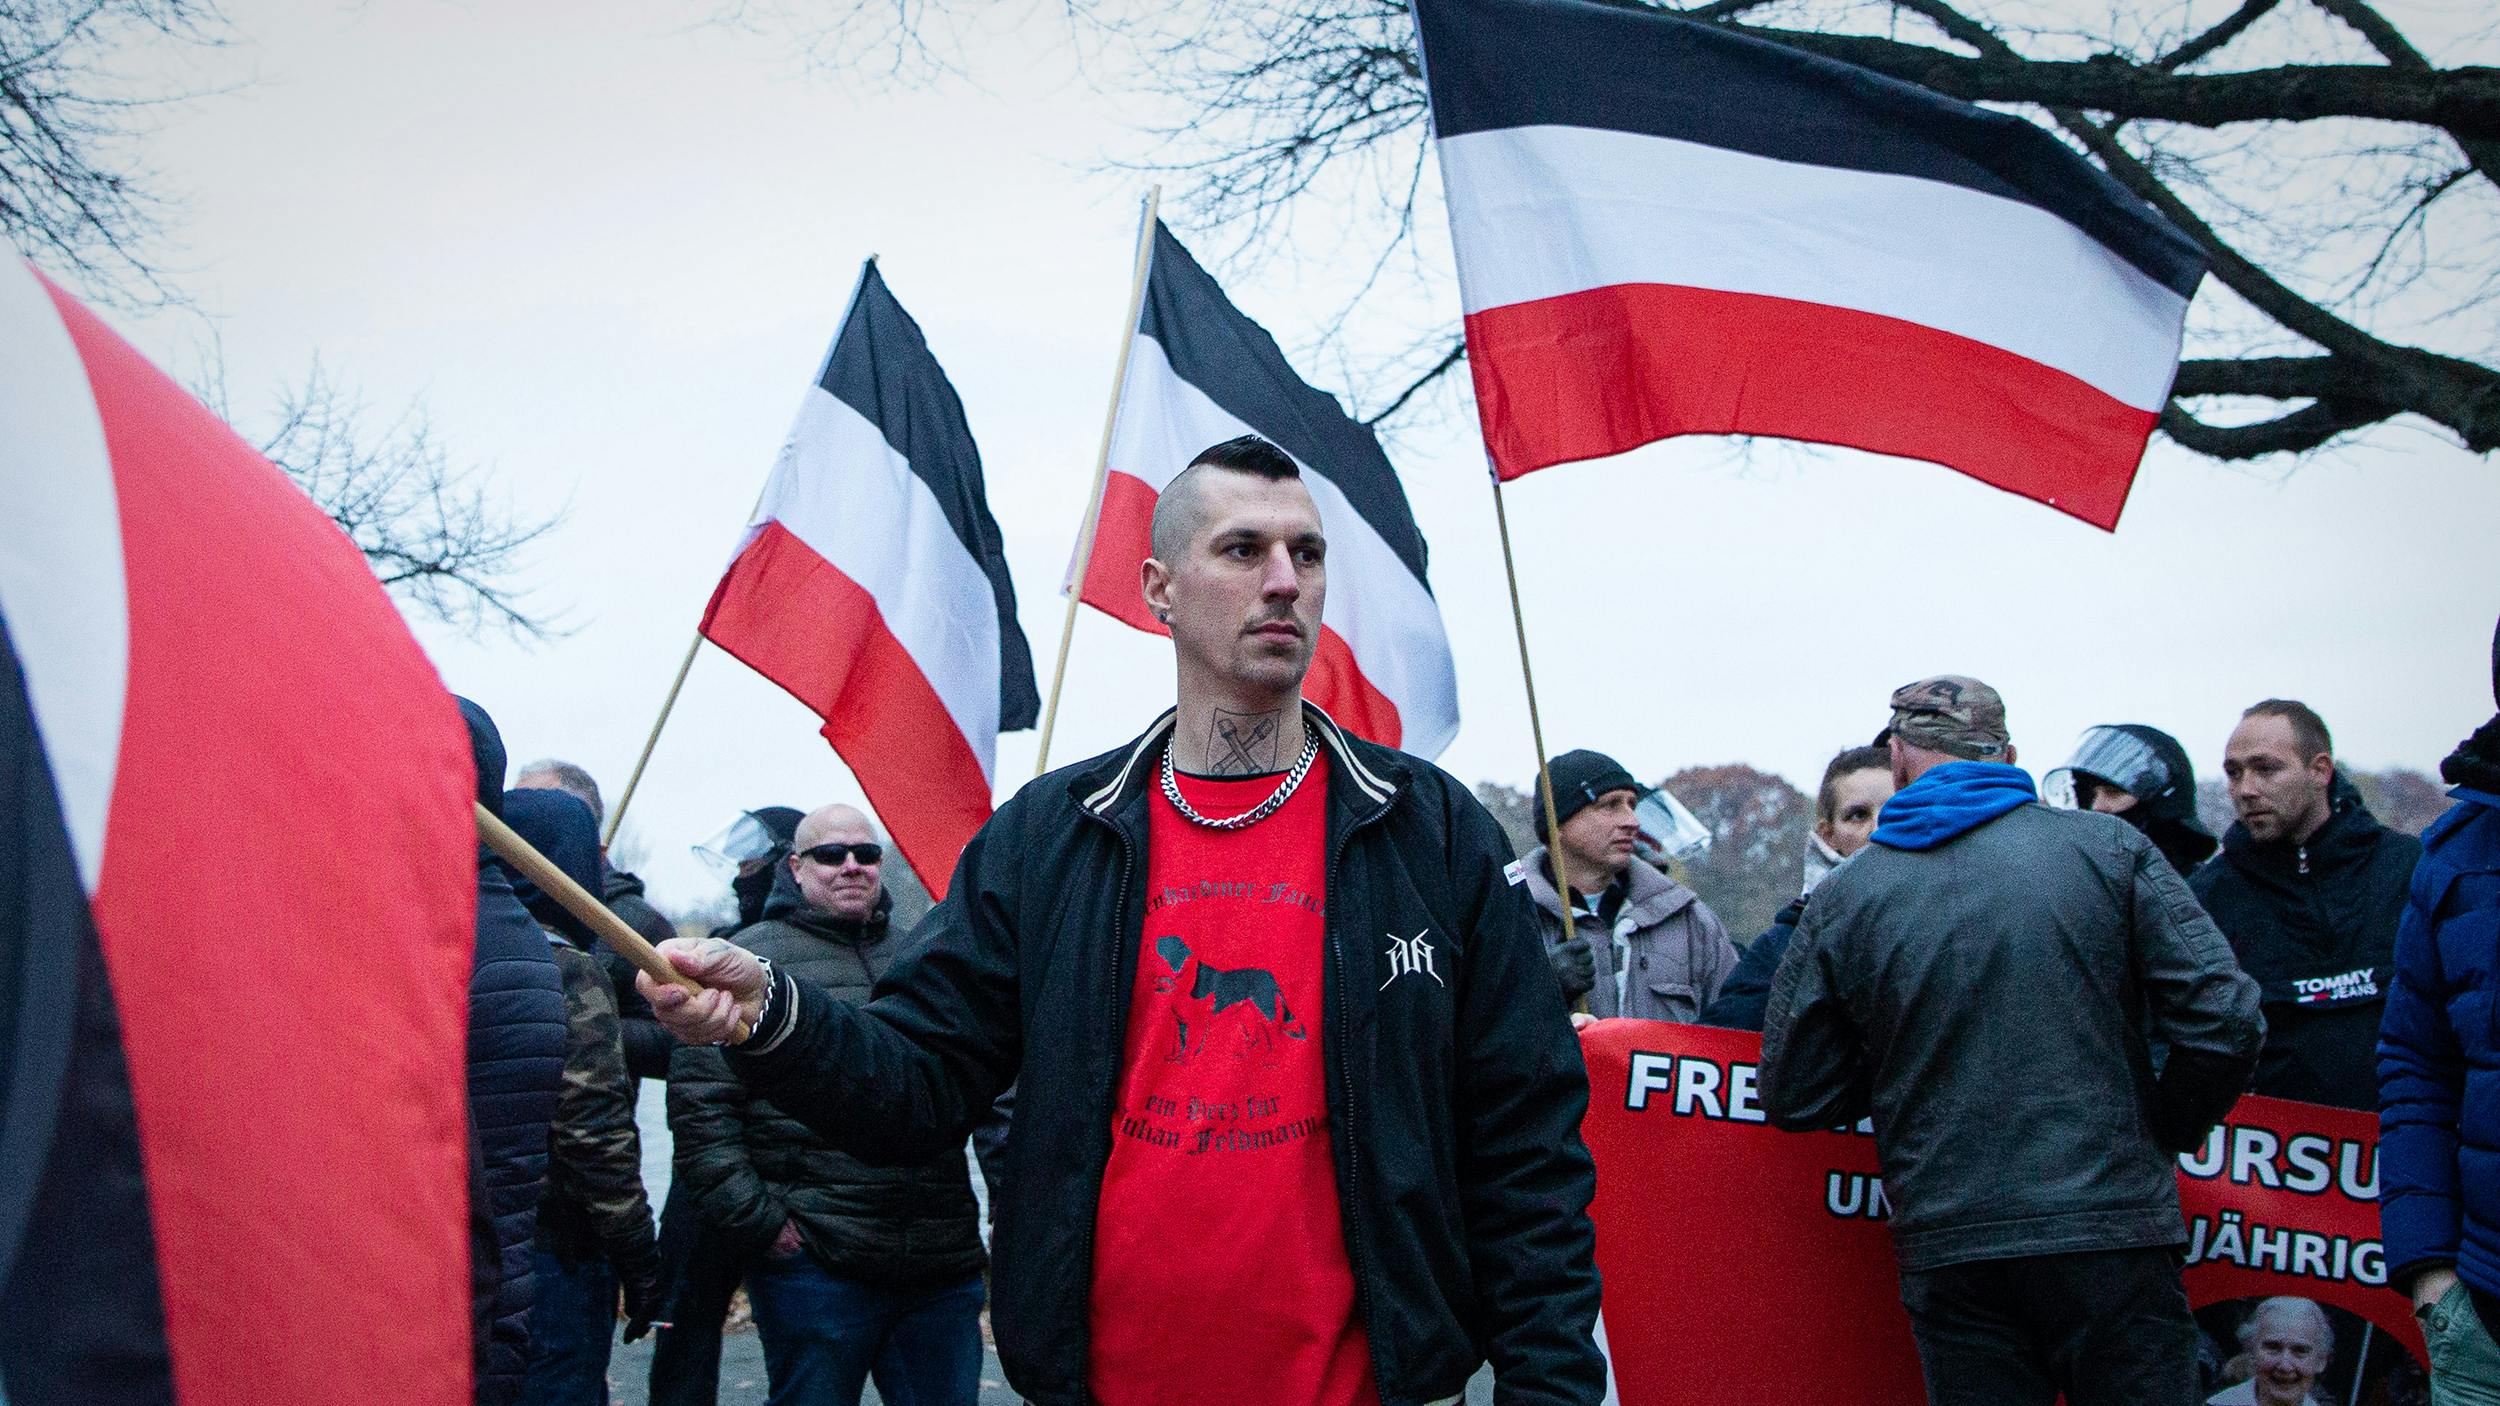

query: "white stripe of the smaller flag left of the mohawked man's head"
xmin=740 ymin=385 xmax=998 ymax=781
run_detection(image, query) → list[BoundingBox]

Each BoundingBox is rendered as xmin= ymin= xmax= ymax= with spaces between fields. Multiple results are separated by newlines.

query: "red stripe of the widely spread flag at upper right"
xmin=1468 ymin=283 xmax=2155 ymax=530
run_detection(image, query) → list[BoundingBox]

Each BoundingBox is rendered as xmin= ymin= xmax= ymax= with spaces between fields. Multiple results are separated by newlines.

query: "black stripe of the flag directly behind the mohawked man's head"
xmin=1138 ymin=220 xmax=1433 ymax=590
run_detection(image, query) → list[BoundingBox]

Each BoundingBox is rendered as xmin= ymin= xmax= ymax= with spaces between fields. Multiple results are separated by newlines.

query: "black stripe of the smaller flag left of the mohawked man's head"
xmin=818 ymin=263 xmax=1043 ymax=733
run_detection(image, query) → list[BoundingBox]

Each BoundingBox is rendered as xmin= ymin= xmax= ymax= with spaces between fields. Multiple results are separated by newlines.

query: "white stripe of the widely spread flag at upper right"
xmin=1440 ymin=128 xmax=2188 ymax=410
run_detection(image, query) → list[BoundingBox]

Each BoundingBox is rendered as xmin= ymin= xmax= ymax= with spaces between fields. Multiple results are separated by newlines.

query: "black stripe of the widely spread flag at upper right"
xmin=1415 ymin=0 xmax=2205 ymax=298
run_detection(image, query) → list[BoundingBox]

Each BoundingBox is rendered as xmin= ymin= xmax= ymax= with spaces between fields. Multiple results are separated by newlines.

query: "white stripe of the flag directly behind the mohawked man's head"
xmin=1110 ymin=335 xmax=1458 ymax=758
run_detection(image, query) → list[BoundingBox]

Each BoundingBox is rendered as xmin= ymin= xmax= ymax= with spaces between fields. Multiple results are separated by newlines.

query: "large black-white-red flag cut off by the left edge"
xmin=0 ymin=258 xmax=478 ymax=1406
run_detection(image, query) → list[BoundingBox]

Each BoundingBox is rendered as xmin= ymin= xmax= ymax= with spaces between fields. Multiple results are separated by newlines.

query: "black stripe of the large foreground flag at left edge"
xmin=0 ymin=620 xmax=176 ymax=1406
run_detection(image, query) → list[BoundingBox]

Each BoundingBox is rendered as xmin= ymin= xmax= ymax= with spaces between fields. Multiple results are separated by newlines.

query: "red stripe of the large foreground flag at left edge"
xmin=48 ymin=271 xmax=478 ymax=1406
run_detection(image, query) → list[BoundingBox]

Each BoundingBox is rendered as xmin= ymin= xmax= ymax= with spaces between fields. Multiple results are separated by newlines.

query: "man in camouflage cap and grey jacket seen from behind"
xmin=1760 ymin=675 xmax=2265 ymax=1406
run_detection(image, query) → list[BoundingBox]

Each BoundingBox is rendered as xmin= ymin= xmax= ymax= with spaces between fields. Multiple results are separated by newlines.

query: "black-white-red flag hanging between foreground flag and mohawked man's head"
xmin=703 ymin=260 xmax=1040 ymax=898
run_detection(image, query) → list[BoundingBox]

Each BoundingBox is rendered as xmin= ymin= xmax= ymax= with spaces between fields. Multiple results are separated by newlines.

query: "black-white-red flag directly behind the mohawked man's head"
xmin=1080 ymin=220 xmax=1458 ymax=758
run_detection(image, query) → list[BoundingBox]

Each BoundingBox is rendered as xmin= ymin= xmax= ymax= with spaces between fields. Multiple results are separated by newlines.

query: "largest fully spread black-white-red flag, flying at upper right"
xmin=1415 ymin=0 xmax=2205 ymax=528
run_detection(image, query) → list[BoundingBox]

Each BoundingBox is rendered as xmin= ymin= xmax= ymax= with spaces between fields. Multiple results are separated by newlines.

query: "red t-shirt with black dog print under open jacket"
xmin=1088 ymin=758 xmax=1378 ymax=1406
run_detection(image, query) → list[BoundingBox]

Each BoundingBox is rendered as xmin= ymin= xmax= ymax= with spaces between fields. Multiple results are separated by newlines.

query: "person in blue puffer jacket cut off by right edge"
xmin=2378 ymin=622 xmax=2500 ymax=1406
